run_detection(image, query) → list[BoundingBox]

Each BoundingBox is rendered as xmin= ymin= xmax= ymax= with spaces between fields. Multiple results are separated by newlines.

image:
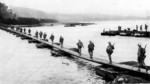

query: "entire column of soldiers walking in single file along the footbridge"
xmin=16 ymin=28 xmax=148 ymax=72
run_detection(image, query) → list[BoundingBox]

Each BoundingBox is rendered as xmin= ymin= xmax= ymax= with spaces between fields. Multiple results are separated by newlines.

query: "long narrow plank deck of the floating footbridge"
xmin=0 ymin=27 xmax=150 ymax=79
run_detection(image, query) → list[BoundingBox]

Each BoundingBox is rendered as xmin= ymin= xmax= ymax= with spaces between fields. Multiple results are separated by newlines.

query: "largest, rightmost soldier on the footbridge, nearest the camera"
xmin=137 ymin=44 xmax=148 ymax=72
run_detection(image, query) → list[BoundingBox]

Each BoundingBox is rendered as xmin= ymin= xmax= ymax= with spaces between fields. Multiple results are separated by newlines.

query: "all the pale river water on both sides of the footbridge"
xmin=0 ymin=21 xmax=150 ymax=84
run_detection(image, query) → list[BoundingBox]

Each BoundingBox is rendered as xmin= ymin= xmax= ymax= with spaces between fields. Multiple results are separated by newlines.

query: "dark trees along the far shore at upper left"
xmin=0 ymin=2 xmax=57 ymax=25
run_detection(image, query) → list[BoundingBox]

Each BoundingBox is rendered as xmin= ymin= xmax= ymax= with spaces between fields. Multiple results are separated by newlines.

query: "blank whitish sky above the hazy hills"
xmin=0 ymin=0 xmax=150 ymax=16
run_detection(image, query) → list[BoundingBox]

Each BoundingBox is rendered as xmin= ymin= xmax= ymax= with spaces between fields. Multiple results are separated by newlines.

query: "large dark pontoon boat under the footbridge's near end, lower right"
xmin=95 ymin=61 xmax=150 ymax=81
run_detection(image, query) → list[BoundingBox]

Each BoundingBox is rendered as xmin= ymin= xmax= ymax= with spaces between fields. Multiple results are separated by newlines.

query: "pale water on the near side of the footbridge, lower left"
xmin=0 ymin=30 xmax=105 ymax=84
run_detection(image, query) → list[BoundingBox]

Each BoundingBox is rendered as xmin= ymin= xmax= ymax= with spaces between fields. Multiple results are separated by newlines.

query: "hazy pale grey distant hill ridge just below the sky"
xmin=10 ymin=7 xmax=147 ymax=22
